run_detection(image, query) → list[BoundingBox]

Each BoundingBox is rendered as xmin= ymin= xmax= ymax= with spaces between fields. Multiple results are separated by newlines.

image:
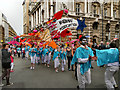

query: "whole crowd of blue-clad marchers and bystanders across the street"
xmin=1 ymin=36 xmax=119 ymax=90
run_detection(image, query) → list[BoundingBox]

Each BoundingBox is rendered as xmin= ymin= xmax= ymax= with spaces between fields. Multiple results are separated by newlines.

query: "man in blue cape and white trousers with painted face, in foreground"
xmin=71 ymin=36 xmax=94 ymax=90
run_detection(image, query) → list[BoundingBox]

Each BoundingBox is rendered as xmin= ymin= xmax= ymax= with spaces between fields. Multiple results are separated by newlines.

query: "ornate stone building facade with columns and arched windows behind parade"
xmin=24 ymin=0 xmax=120 ymax=43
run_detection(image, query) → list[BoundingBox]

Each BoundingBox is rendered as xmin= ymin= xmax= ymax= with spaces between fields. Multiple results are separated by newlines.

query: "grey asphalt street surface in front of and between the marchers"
xmin=3 ymin=57 xmax=120 ymax=90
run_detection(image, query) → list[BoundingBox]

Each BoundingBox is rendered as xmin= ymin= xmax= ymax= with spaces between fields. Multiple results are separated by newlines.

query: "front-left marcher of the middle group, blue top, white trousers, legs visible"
xmin=30 ymin=44 xmax=36 ymax=70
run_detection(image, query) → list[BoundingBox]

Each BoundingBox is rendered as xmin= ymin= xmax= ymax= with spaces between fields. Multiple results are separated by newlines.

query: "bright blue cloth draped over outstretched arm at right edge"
xmin=96 ymin=48 xmax=119 ymax=66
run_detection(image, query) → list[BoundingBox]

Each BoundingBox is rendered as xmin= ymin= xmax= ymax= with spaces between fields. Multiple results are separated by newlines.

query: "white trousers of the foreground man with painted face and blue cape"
xmin=77 ymin=64 xmax=91 ymax=90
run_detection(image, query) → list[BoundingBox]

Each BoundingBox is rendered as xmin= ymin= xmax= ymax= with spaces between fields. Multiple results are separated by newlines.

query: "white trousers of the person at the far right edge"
xmin=105 ymin=66 xmax=119 ymax=90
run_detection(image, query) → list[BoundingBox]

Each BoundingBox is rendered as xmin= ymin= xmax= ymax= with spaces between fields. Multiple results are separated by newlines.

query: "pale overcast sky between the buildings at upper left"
xmin=0 ymin=0 xmax=24 ymax=35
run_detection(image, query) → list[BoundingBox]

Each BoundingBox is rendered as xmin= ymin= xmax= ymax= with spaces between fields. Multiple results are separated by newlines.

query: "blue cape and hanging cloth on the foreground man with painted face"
xmin=71 ymin=47 xmax=94 ymax=75
